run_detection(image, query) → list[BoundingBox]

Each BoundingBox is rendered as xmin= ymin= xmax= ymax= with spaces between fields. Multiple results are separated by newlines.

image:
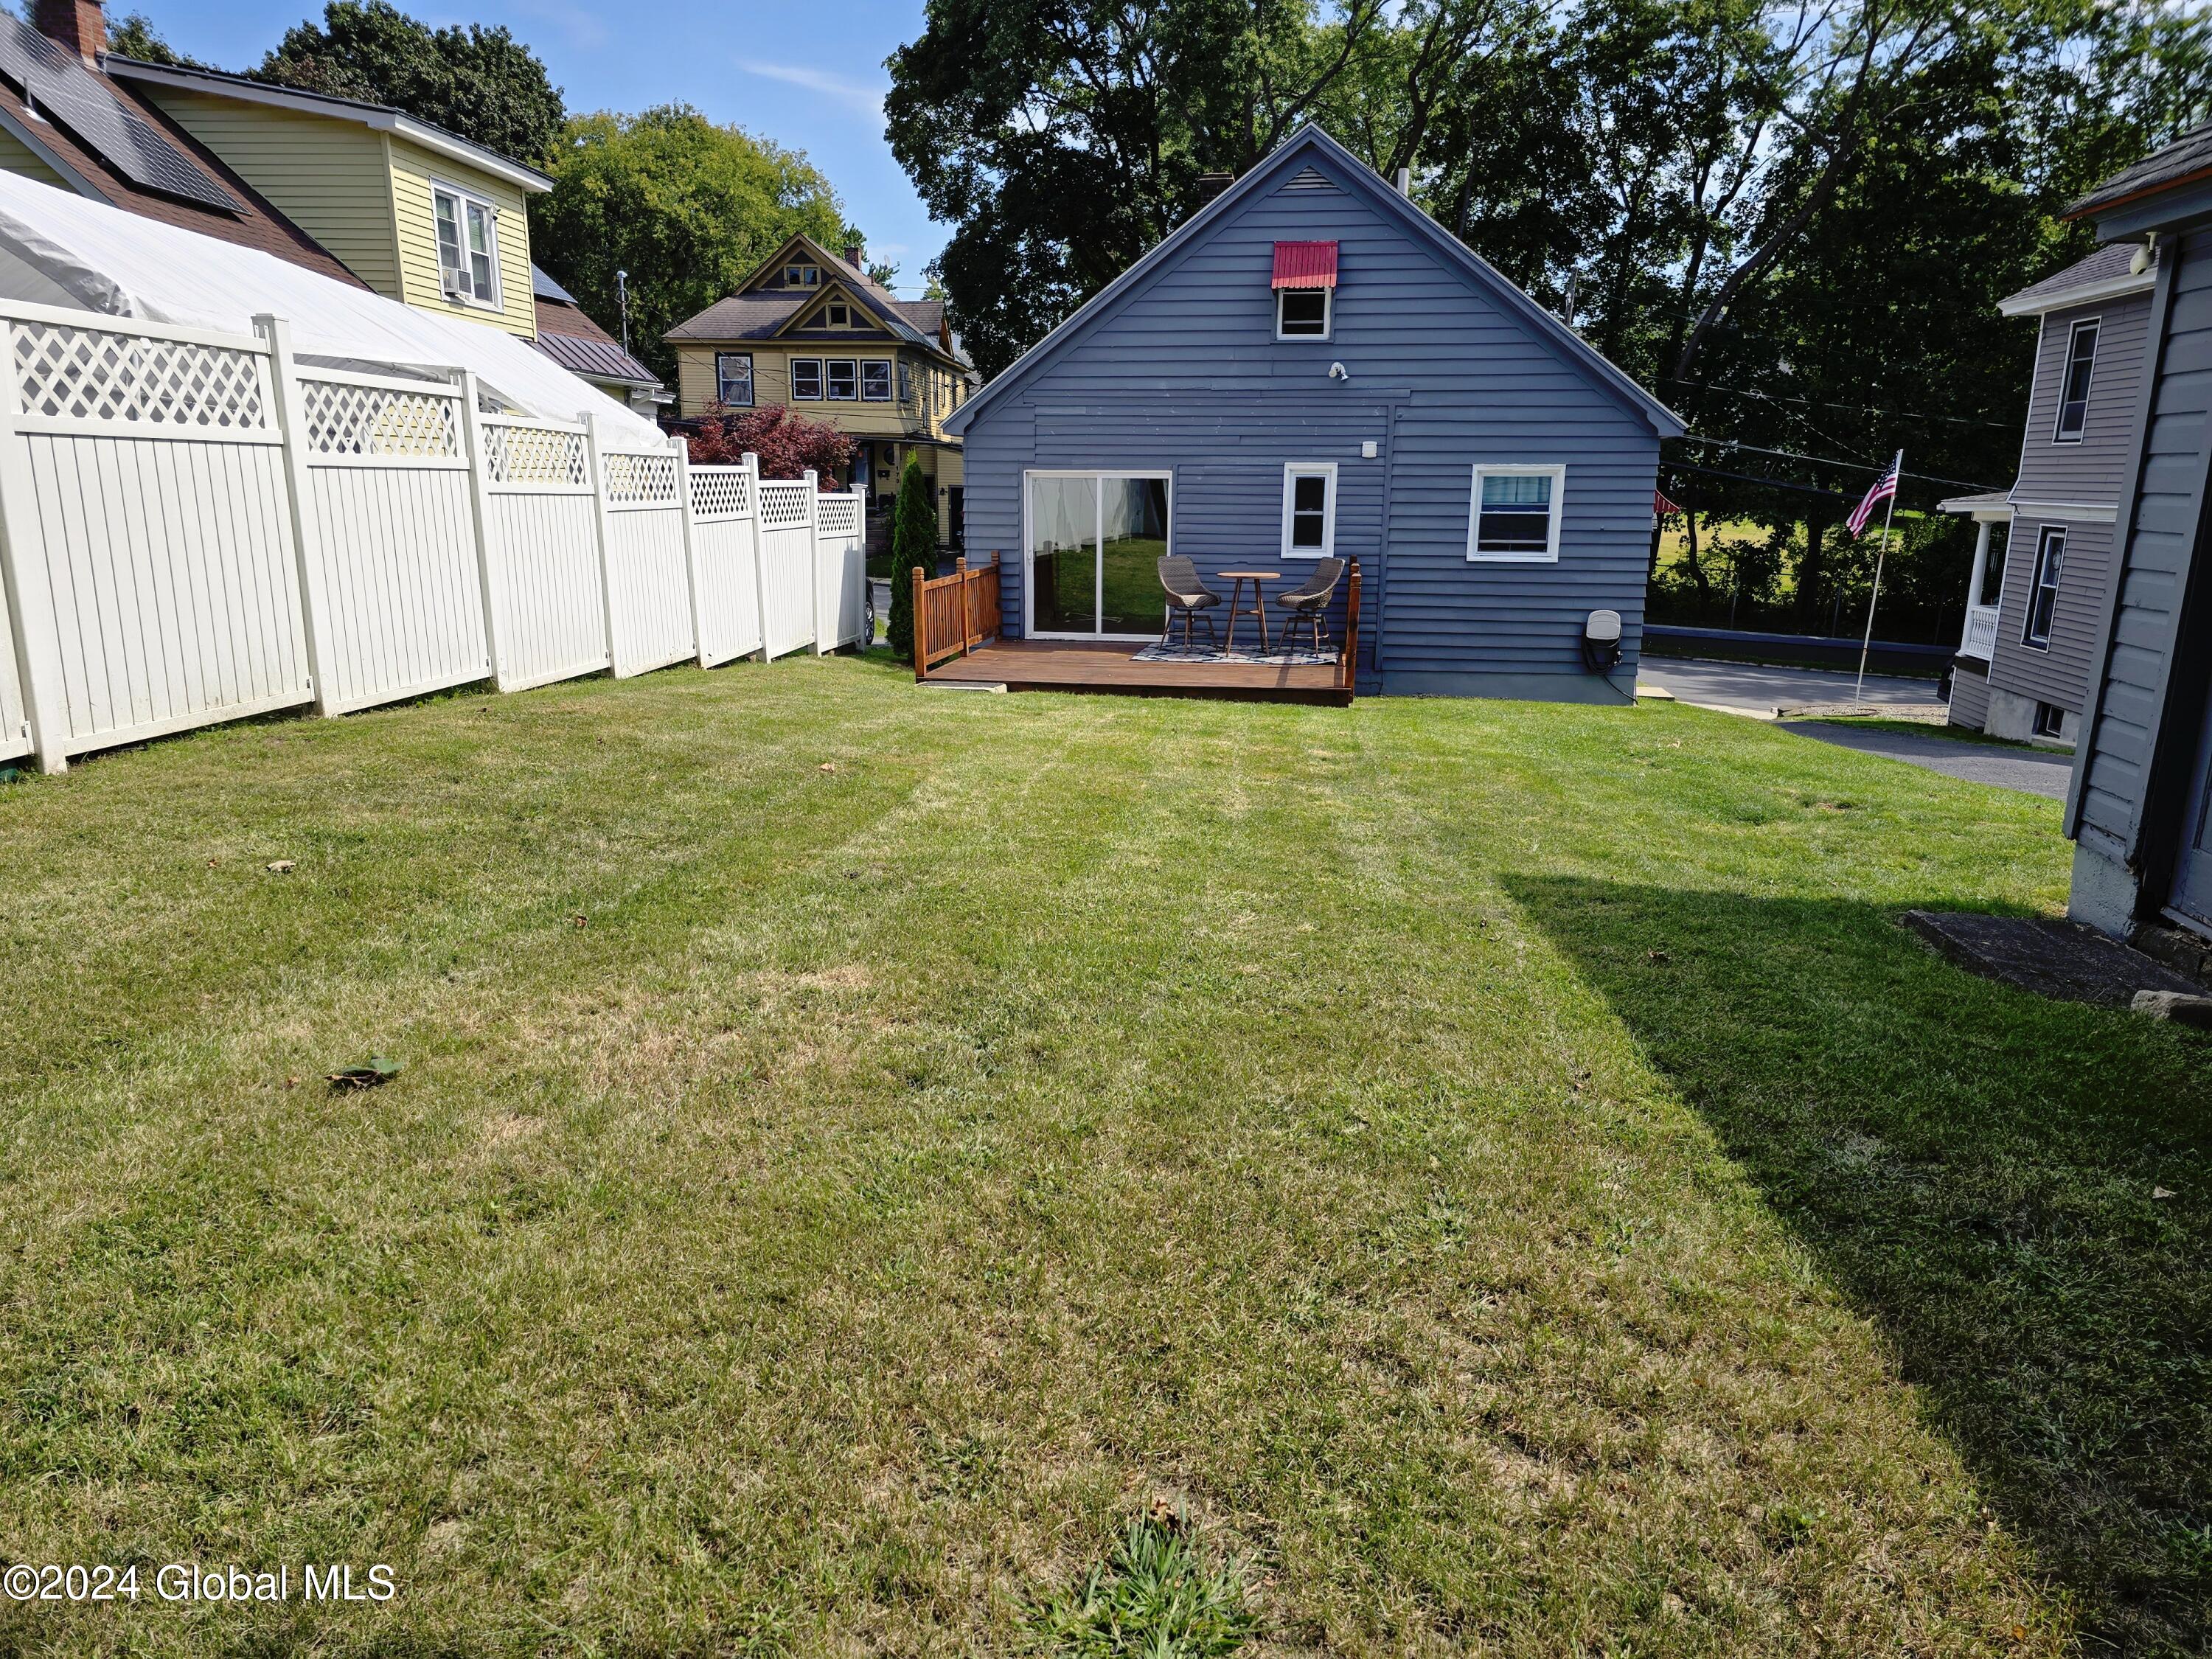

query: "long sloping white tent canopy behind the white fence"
xmin=0 ymin=173 xmax=666 ymax=445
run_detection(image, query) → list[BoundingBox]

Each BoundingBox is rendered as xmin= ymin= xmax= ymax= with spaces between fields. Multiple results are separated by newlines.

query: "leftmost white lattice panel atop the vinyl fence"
xmin=9 ymin=321 xmax=270 ymax=431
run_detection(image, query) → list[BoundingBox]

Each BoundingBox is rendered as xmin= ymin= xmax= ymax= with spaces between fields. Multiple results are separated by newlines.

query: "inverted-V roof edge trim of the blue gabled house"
xmin=945 ymin=124 xmax=1688 ymax=438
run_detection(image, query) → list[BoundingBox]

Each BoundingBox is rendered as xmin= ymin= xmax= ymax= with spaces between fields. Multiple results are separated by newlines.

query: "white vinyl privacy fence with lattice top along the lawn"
xmin=0 ymin=303 xmax=867 ymax=772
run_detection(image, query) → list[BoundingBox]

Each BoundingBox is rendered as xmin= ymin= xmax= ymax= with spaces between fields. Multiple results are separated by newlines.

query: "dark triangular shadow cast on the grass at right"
xmin=1506 ymin=876 xmax=2212 ymax=1655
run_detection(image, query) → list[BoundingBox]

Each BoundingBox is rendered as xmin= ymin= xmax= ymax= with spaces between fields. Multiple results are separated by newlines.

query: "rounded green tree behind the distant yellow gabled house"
xmin=531 ymin=104 xmax=860 ymax=383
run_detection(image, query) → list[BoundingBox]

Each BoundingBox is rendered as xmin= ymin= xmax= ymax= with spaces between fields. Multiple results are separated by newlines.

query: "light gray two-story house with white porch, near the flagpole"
xmin=1942 ymin=243 xmax=2152 ymax=748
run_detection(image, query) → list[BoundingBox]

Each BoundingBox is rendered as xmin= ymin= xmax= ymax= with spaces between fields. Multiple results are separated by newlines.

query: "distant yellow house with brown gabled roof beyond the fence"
xmin=666 ymin=237 xmax=975 ymax=544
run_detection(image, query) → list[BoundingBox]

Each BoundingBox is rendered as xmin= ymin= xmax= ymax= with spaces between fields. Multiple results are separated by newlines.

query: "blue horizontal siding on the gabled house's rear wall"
xmin=964 ymin=136 xmax=1659 ymax=695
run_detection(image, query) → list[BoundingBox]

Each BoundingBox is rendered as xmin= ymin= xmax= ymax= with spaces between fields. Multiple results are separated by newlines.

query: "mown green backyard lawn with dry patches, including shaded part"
xmin=0 ymin=659 xmax=2212 ymax=1657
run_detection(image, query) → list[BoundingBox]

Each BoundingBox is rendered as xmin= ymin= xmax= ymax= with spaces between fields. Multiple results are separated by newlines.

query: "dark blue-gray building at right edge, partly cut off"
xmin=2066 ymin=124 xmax=2212 ymax=938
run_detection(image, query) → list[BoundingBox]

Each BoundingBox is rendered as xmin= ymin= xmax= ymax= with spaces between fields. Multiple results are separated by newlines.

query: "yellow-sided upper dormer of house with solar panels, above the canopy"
xmin=102 ymin=53 xmax=553 ymax=338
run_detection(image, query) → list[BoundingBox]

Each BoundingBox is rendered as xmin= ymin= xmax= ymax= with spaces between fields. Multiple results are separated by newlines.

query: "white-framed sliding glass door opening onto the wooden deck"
xmin=1029 ymin=473 xmax=1168 ymax=639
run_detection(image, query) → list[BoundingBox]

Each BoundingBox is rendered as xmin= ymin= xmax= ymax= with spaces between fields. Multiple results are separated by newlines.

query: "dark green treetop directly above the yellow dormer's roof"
xmin=250 ymin=0 xmax=566 ymax=166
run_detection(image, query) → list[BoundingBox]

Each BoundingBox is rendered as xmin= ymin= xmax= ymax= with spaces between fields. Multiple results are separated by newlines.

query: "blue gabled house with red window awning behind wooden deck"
xmin=947 ymin=126 xmax=1683 ymax=701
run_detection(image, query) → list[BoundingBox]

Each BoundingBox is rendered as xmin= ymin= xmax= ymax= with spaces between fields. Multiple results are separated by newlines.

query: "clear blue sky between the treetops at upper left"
xmin=125 ymin=0 xmax=945 ymax=296
